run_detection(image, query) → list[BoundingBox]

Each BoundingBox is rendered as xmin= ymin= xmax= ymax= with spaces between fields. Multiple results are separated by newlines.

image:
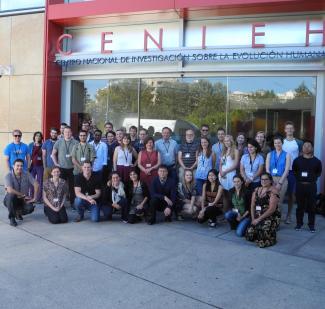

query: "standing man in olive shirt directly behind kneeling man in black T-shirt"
xmin=71 ymin=130 xmax=96 ymax=175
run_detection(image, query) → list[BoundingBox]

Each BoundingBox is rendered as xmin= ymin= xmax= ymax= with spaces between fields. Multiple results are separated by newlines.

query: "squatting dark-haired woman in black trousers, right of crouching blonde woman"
xmin=198 ymin=169 xmax=223 ymax=227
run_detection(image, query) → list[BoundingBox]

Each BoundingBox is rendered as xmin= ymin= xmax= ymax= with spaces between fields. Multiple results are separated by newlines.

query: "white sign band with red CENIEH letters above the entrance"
xmin=55 ymin=19 xmax=325 ymax=66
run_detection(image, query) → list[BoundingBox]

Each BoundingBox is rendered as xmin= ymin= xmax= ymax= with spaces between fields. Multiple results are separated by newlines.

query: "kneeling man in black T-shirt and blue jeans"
xmin=74 ymin=161 xmax=104 ymax=222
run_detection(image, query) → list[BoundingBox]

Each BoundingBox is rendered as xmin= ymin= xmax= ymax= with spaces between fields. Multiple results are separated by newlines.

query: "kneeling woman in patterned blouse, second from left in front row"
xmin=43 ymin=166 xmax=69 ymax=224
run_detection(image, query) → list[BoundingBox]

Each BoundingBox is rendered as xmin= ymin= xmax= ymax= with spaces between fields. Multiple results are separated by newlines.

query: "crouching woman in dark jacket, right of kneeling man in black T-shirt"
xmin=102 ymin=172 xmax=129 ymax=223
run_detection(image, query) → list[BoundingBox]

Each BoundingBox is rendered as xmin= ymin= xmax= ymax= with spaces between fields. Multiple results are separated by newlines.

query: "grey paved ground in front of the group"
xmin=0 ymin=188 xmax=325 ymax=309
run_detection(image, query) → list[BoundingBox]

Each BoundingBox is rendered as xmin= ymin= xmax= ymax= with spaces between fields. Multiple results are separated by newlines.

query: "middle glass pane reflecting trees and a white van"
xmin=140 ymin=78 xmax=227 ymax=142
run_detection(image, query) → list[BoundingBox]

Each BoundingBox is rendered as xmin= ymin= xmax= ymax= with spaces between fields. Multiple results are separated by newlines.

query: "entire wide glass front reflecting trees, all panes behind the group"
xmin=71 ymin=77 xmax=316 ymax=143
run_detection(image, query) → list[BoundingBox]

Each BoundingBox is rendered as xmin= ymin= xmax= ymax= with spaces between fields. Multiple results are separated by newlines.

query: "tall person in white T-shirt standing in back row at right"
xmin=282 ymin=121 xmax=302 ymax=224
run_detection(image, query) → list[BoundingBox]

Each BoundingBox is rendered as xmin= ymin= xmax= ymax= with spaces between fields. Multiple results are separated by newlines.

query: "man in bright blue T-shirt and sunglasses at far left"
xmin=4 ymin=129 xmax=30 ymax=171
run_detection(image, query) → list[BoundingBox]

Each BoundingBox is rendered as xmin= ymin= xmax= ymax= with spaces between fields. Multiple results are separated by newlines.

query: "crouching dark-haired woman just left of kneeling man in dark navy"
xmin=126 ymin=171 xmax=149 ymax=224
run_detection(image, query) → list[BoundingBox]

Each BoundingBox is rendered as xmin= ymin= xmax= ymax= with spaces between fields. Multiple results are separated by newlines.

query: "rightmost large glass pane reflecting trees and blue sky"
xmin=229 ymin=77 xmax=316 ymax=139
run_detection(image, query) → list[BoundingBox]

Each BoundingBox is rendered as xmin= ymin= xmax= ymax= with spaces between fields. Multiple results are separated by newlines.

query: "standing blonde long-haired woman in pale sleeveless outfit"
xmin=219 ymin=135 xmax=239 ymax=211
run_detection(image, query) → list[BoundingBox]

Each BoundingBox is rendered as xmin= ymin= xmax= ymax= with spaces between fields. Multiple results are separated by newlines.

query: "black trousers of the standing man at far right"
xmin=296 ymin=182 xmax=317 ymax=227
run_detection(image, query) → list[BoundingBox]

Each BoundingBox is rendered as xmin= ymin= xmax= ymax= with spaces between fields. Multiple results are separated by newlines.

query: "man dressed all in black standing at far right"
xmin=292 ymin=140 xmax=322 ymax=233
